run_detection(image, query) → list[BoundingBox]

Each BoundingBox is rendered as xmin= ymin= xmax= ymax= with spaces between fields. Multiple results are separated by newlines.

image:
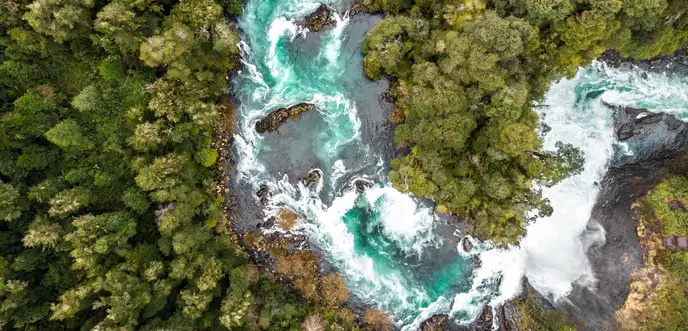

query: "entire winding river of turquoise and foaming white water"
xmin=233 ymin=0 xmax=688 ymax=330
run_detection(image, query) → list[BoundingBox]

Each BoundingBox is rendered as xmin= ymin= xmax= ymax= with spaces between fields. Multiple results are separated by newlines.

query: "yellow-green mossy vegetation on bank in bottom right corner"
xmin=617 ymin=173 xmax=688 ymax=331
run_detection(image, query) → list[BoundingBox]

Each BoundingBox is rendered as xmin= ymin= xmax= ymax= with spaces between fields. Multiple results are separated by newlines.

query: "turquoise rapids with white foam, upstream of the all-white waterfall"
xmin=234 ymin=1 xmax=484 ymax=329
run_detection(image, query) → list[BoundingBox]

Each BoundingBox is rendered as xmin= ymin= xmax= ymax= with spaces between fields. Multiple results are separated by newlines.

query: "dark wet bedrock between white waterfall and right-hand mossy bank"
xmin=560 ymin=105 xmax=688 ymax=330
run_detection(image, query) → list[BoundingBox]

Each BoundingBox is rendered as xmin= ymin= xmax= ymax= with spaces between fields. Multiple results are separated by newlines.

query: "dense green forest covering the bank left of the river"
xmin=0 ymin=0 xmax=360 ymax=330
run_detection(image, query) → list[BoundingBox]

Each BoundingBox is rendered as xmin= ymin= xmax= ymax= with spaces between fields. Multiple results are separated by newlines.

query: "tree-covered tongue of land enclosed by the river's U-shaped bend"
xmin=362 ymin=0 xmax=688 ymax=242
